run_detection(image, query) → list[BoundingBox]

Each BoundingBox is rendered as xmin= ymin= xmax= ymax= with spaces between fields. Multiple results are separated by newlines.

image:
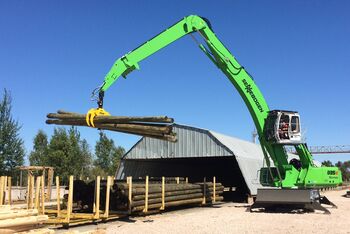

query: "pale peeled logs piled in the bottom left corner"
xmin=0 ymin=206 xmax=51 ymax=233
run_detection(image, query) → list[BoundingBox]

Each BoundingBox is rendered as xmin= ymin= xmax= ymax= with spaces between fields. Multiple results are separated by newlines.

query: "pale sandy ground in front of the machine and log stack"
xmin=61 ymin=190 xmax=350 ymax=234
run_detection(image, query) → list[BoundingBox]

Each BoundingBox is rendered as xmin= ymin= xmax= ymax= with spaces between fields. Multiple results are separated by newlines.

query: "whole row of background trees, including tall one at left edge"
xmin=0 ymin=89 xmax=125 ymax=182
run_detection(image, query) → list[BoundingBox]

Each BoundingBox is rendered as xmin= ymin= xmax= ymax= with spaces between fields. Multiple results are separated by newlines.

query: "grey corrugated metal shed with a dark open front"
xmin=117 ymin=124 xmax=263 ymax=195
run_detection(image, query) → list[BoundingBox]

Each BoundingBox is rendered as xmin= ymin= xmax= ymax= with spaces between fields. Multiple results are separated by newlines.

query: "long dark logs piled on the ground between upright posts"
xmin=65 ymin=179 xmax=224 ymax=213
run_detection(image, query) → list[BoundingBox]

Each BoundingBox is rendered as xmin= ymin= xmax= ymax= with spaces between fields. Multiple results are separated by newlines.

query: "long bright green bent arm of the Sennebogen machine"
xmin=99 ymin=15 xmax=269 ymax=135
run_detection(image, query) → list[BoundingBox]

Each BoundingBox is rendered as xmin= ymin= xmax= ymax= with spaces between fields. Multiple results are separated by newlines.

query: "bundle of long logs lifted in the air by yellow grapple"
xmin=46 ymin=110 xmax=176 ymax=142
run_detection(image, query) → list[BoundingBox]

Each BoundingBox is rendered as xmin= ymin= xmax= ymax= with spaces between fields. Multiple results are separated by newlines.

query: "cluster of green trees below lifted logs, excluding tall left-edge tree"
xmin=29 ymin=127 xmax=125 ymax=182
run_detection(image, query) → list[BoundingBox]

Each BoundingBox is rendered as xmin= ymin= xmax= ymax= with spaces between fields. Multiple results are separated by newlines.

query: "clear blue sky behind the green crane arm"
xmin=0 ymin=0 xmax=350 ymax=164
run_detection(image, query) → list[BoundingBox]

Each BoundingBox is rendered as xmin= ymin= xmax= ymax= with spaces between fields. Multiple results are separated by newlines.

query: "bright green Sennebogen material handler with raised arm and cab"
xmin=89 ymin=15 xmax=342 ymax=213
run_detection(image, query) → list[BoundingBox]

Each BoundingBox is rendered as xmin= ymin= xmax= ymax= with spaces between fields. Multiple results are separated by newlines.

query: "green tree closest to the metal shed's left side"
xmin=94 ymin=132 xmax=125 ymax=175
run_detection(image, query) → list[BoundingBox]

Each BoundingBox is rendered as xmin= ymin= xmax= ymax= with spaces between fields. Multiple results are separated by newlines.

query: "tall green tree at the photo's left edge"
xmin=0 ymin=89 xmax=25 ymax=176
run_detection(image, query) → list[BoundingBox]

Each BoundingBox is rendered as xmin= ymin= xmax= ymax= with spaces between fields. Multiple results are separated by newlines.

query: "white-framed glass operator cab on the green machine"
xmin=264 ymin=110 xmax=301 ymax=145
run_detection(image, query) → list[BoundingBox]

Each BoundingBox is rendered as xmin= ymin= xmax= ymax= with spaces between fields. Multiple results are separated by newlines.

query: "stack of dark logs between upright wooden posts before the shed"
xmin=69 ymin=180 xmax=224 ymax=214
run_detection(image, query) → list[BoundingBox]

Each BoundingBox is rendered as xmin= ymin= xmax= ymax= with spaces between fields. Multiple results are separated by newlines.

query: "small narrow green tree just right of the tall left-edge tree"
xmin=29 ymin=130 xmax=49 ymax=166
